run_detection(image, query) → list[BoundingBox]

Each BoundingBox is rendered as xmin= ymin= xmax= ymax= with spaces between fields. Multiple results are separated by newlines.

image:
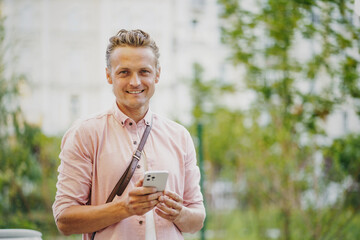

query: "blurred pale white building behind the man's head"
xmin=3 ymin=0 xmax=235 ymax=134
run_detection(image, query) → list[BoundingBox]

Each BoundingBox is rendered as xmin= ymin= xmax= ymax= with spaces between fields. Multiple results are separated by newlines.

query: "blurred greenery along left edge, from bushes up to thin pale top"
xmin=0 ymin=5 xmax=60 ymax=236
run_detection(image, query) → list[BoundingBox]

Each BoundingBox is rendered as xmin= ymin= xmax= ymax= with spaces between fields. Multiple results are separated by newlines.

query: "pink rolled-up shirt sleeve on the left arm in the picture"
xmin=53 ymin=124 xmax=92 ymax=221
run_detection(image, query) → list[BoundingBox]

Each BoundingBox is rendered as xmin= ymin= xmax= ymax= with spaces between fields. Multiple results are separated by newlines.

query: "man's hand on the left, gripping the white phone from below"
xmin=125 ymin=179 xmax=163 ymax=215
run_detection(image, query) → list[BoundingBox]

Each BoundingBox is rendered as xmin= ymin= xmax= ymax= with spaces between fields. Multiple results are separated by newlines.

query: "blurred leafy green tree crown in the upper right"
xmin=219 ymin=0 xmax=360 ymax=120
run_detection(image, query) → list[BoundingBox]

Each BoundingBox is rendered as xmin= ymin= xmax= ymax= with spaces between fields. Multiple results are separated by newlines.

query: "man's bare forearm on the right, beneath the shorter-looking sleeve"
xmin=174 ymin=203 xmax=206 ymax=233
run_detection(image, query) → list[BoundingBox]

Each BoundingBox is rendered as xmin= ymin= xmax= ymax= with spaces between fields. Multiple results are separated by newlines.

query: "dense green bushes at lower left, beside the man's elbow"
xmin=0 ymin=100 xmax=60 ymax=231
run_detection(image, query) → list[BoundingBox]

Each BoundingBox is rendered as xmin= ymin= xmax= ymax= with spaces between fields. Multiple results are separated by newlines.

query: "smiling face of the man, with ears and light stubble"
xmin=106 ymin=47 xmax=160 ymax=117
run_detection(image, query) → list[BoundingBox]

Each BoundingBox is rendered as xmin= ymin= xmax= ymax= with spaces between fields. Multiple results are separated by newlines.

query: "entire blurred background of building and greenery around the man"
xmin=0 ymin=0 xmax=360 ymax=240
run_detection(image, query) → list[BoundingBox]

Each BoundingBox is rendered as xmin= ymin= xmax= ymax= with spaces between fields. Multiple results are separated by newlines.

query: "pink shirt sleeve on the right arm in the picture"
xmin=183 ymin=131 xmax=203 ymax=208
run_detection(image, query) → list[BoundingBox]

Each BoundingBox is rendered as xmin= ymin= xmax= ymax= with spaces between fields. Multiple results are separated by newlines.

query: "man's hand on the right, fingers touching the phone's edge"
xmin=155 ymin=191 xmax=183 ymax=222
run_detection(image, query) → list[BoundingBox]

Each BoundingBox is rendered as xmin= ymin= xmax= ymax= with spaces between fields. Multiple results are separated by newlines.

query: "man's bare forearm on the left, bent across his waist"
xmin=56 ymin=202 xmax=130 ymax=235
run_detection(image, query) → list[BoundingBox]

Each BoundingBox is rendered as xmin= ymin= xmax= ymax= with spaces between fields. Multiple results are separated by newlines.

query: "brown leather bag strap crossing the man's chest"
xmin=91 ymin=121 xmax=151 ymax=240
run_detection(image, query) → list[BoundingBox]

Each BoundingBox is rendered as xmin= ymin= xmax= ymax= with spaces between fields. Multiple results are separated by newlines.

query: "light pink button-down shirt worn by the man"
xmin=53 ymin=104 xmax=203 ymax=240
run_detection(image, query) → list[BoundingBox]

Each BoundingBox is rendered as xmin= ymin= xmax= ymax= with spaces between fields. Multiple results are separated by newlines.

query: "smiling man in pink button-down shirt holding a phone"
xmin=53 ymin=30 xmax=205 ymax=240
